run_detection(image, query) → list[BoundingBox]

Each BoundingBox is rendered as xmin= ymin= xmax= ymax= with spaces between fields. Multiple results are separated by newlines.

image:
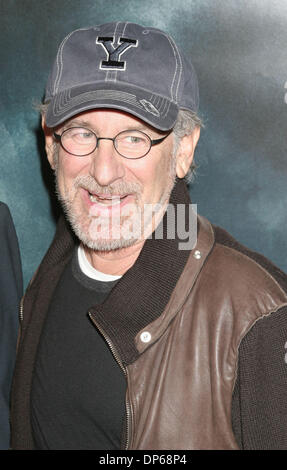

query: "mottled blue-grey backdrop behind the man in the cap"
xmin=0 ymin=0 xmax=287 ymax=284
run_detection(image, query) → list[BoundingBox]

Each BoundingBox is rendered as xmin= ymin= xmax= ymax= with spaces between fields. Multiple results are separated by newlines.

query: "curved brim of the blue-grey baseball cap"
xmin=46 ymin=82 xmax=179 ymax=131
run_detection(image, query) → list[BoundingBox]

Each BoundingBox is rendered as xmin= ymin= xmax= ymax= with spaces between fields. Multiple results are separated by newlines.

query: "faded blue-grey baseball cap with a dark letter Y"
xmin=44 ymin=22 xmax=199 ymax=130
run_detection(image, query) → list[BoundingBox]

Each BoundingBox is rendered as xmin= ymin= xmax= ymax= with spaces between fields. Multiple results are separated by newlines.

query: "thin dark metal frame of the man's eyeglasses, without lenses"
xmin=53 ymin=126 xmax=173 ymax=160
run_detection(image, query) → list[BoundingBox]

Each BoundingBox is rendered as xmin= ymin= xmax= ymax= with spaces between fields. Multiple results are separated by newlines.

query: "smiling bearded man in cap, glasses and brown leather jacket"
xmin=11 ymin=23 xmax=287 ymax=450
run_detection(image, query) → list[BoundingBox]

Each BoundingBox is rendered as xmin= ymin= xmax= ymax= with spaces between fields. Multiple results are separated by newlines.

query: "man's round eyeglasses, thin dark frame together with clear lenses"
xmin=54 ymin=127 xmax=172 ymax=159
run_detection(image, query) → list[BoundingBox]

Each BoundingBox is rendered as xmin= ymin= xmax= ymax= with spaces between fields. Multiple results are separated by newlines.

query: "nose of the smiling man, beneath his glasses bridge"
xmin=89 ymin=139 xmax=125 ymax=186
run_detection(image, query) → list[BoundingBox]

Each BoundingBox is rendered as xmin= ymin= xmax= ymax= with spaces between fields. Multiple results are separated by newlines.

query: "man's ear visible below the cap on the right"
xmin=176 ymin=126 xmax=200 ymax=178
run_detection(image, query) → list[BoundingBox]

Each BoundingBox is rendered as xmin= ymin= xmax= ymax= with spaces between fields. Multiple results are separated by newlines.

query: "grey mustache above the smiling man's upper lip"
xmin=73 ymin=175 xmax=142 ymax=196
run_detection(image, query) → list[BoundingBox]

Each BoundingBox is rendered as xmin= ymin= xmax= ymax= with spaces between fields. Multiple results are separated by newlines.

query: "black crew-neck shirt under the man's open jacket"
xmin=31 ymin=248 xmax=126 ymax=450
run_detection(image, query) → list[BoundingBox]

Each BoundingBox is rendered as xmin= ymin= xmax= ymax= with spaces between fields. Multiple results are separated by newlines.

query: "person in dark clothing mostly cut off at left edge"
xmin=0 ymin=202 xmax=23 ymax=450
